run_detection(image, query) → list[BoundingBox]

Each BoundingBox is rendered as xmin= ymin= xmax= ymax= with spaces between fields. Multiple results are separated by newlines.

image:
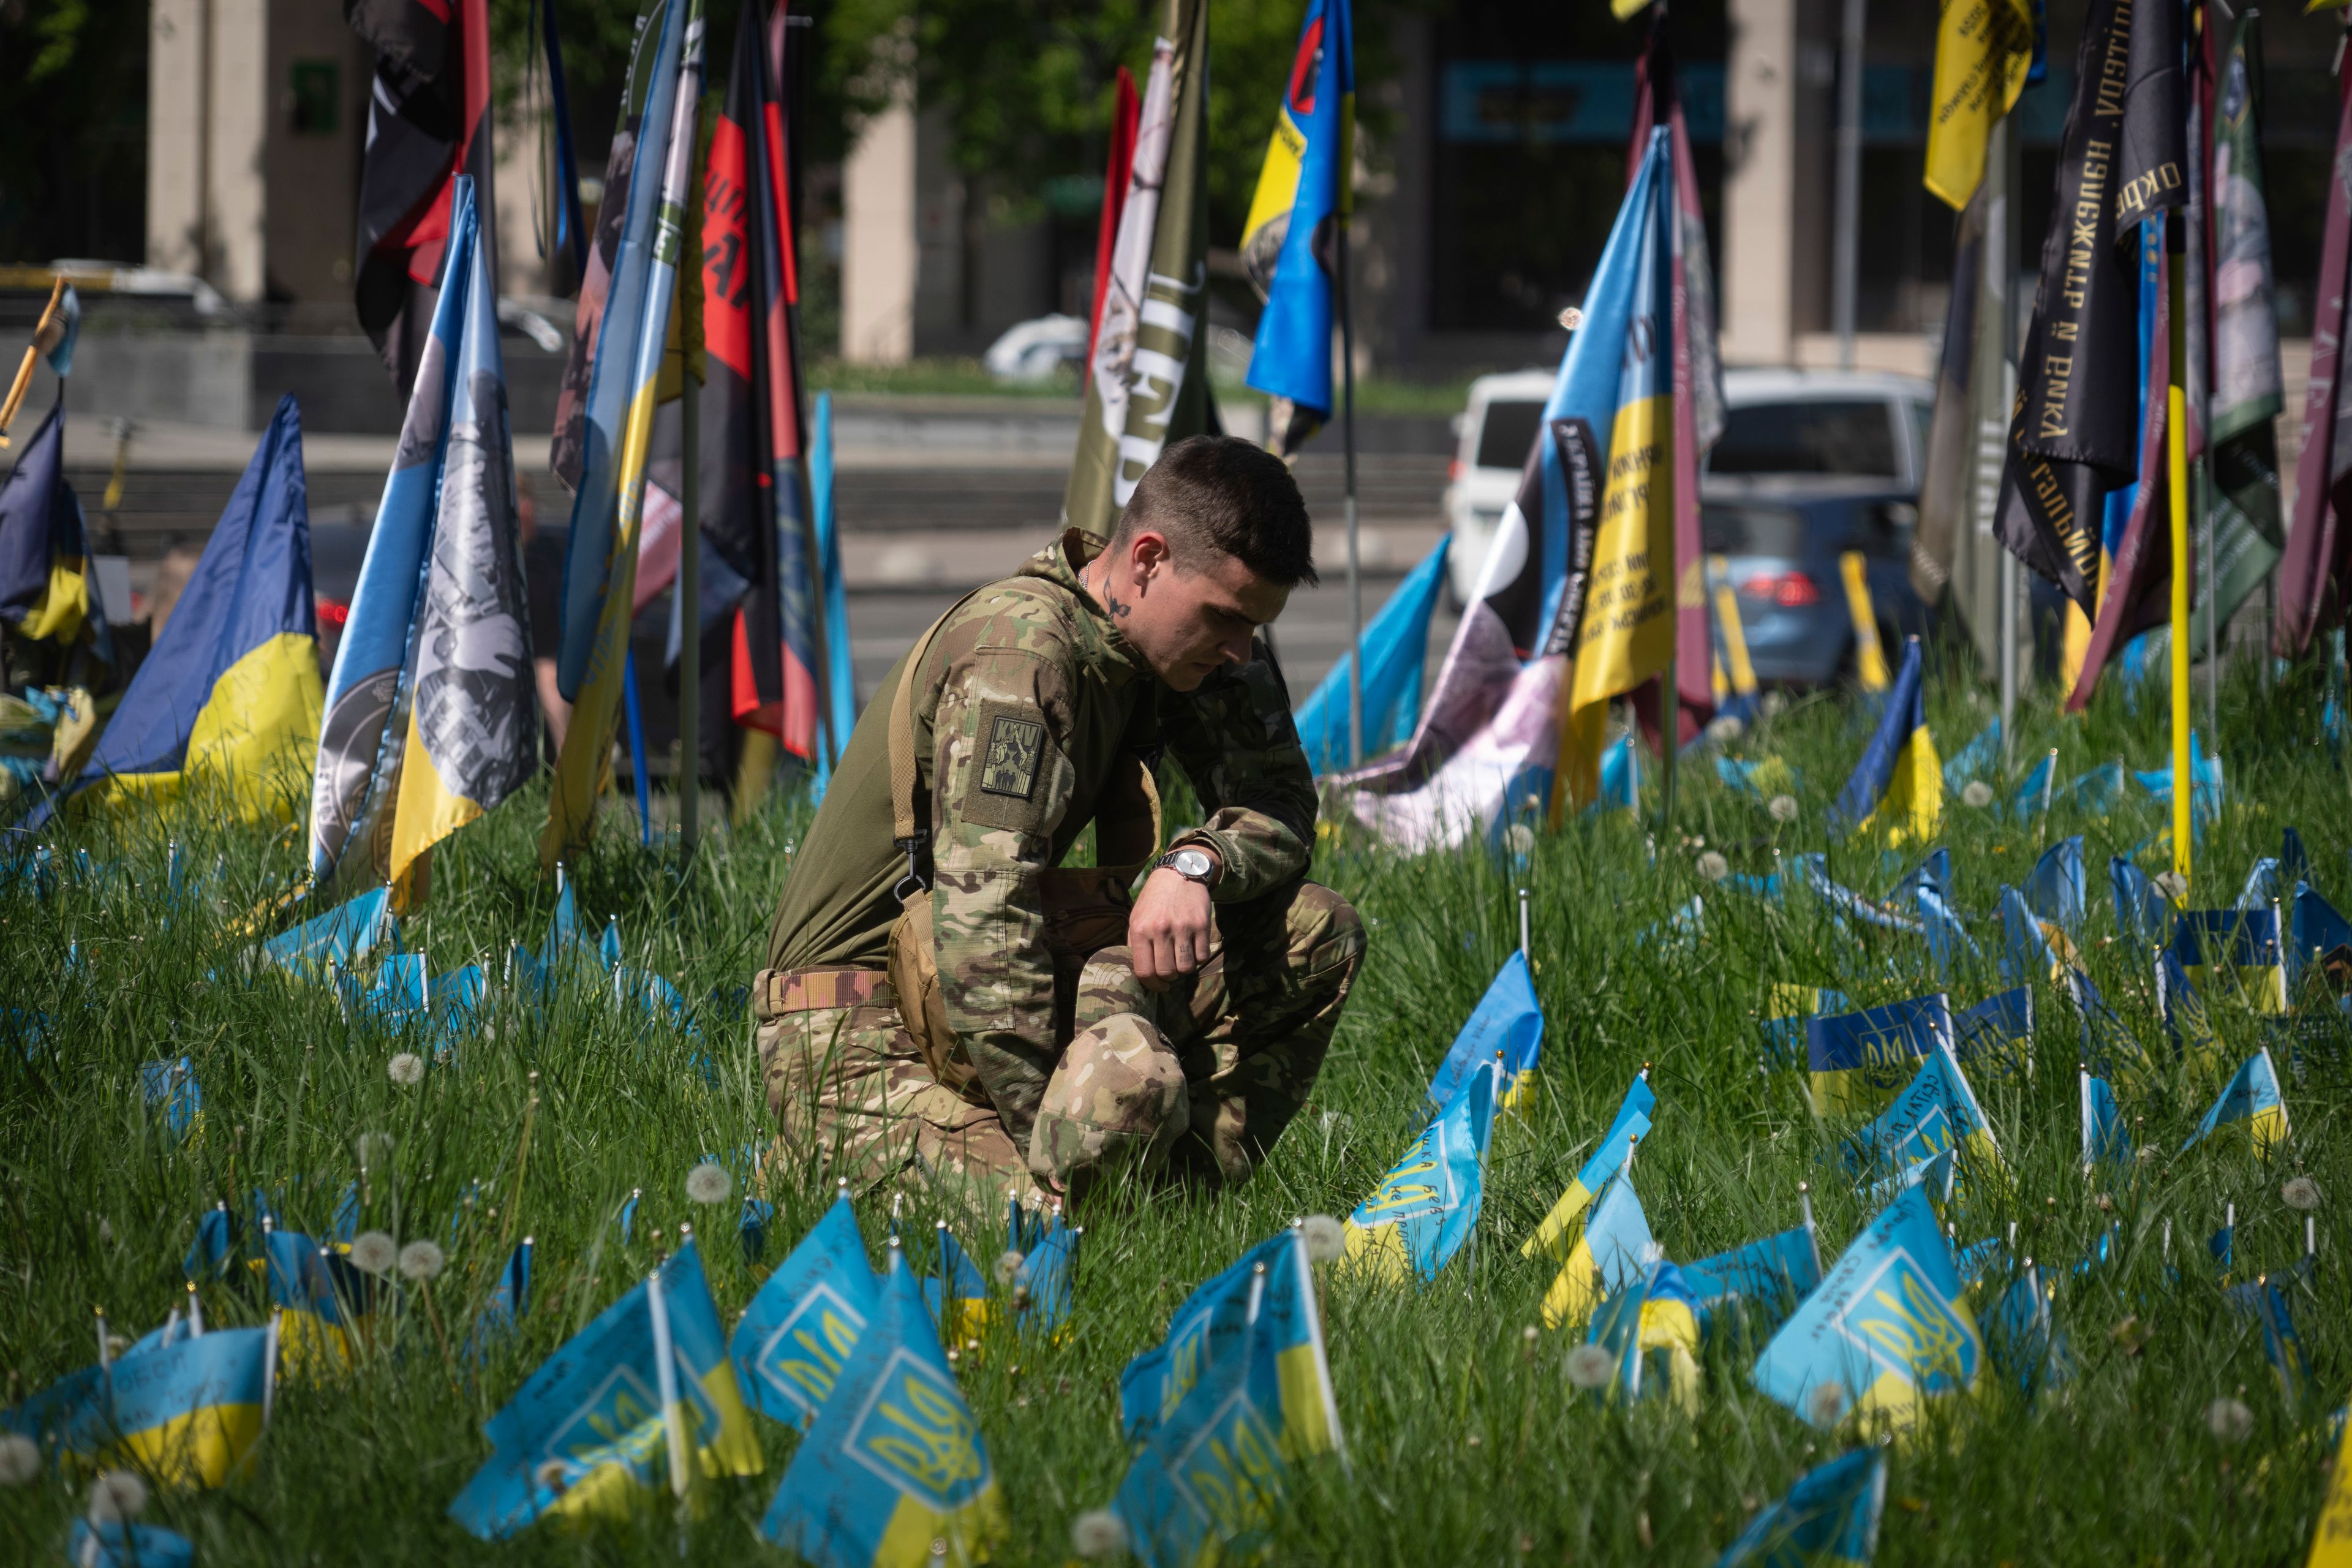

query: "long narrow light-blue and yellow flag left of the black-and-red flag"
xmin=538 ymin=0 xmax=703 ymax=865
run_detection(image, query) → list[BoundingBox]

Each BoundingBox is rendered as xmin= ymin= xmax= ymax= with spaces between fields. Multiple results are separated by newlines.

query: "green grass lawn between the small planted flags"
xmin=0 ymin=644 xmax=2352 ymax=1568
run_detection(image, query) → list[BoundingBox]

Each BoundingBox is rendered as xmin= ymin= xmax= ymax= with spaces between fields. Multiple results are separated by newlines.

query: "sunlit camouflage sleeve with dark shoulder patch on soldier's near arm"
xmin=932 ymin=614 xmax=1075 ymax=1147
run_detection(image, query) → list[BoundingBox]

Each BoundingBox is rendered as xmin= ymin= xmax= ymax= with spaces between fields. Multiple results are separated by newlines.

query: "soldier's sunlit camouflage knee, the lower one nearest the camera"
xmin=1028 ymin=1013 xmax=1190 ymax=1189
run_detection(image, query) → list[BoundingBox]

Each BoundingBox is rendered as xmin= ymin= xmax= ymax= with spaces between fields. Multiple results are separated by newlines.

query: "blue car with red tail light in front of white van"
xmin=1698 ymin=480 xmax=1931 ymax=687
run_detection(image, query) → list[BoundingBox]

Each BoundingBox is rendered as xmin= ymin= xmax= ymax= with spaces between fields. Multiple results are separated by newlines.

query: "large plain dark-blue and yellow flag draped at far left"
xmin=64 ymin=395 xmax=322 ymax=820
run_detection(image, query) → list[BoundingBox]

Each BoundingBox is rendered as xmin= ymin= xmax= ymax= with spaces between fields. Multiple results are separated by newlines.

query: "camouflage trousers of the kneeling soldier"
xmin=753 ymin=881 xmax=1364 ymax=1204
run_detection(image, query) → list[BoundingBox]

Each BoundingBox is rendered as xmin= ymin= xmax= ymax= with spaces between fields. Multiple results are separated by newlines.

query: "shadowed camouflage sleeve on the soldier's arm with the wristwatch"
xmin=1159 ymin=642 xmax=1315 ymax=903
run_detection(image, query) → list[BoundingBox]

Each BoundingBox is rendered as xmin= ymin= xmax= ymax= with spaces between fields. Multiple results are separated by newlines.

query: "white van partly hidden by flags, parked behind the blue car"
xmin=1444 ymin=369 xmax=1936 ymax=604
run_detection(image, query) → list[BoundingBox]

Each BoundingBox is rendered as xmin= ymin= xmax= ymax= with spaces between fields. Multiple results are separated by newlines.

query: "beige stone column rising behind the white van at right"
xmin=1722 ymin=0 xmax=1797 ymax=364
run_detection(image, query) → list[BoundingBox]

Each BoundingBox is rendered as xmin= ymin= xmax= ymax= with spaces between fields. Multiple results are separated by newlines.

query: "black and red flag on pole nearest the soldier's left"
xmin=701 ymin=0 xmax=821 ymax=760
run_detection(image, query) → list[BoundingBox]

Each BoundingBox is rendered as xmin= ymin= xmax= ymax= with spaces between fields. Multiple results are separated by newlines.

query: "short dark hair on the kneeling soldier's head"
xmin=1112 ymin=435 xmax=1317 ymax=588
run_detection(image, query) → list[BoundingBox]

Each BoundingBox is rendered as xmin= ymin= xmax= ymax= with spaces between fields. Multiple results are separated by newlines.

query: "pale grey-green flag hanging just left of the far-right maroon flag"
xmin=2190 ymin=12 xmax=2286 ymax=646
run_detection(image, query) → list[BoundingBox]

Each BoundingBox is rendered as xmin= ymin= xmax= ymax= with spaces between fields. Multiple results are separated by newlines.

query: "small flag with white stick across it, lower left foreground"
xmin=449 ymin=1242 xmax=762 ymax=1540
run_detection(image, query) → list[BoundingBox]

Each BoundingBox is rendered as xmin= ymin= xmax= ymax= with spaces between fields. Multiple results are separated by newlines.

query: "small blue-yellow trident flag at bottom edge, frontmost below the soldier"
xmin=760 ymin=1242 xmax=1007 ymax=1568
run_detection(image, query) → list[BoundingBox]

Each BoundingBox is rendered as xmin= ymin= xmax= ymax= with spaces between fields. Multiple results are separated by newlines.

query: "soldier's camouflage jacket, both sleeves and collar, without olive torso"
xmin=922 ymin=529 xmax=1317 ymax=1142
